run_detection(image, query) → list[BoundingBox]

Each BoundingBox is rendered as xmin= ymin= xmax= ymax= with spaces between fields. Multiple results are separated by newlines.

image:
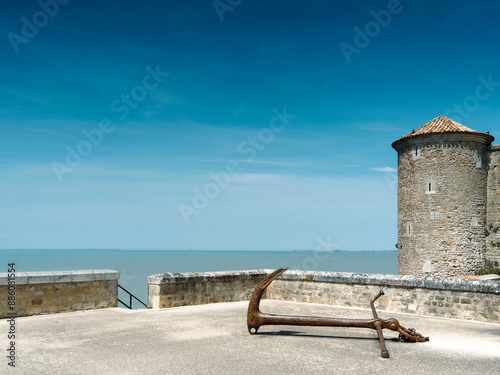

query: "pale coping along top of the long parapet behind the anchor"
xmin=148 ymin=269 xmax=500 ymax=294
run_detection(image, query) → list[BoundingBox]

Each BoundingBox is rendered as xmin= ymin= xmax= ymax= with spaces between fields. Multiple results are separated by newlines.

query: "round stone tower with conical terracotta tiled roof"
xmin=392 ymin=116 xmax=494 ymax=276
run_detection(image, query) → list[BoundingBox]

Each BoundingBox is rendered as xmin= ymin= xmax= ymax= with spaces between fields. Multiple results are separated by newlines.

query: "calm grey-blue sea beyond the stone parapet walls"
xmin=0 ymin=249 xmax=398 ymax=308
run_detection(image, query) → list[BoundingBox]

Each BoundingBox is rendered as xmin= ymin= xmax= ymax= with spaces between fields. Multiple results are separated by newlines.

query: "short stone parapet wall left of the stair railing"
xmin=0 ymin=270 xmax=120 ymax=318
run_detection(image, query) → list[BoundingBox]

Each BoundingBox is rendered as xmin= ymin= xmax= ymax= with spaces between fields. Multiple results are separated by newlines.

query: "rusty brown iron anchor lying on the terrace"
xmin=247 ymin=268 xmax=429 ymax=358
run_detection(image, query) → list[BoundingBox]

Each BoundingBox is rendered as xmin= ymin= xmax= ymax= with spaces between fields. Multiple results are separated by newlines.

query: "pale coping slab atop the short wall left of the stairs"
xmin=0 ymin=270 xmax=120 ymax=285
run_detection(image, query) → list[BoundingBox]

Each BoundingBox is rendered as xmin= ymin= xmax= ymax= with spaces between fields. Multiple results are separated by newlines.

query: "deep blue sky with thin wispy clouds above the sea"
xmin=0 ymin=0 xmax=500 ymax=250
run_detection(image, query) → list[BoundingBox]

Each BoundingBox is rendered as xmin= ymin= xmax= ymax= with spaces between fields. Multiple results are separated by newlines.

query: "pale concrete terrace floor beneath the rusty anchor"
xmin=0 ymin=300 xmax=500 ymax=375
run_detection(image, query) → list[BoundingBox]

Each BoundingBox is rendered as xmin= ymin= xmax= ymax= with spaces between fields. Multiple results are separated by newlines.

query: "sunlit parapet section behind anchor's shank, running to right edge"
xmin=267 ymin=271 xmax=500 ymax=323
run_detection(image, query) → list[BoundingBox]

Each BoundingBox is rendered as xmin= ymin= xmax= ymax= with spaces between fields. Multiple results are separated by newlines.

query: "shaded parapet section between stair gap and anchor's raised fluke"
xmin=148 ymin=270 xmax=269 ymax=309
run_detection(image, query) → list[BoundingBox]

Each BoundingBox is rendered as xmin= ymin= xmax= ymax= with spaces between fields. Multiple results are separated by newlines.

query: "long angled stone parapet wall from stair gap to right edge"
xmin=148 ymin=270 xmax=500 ymax=323
